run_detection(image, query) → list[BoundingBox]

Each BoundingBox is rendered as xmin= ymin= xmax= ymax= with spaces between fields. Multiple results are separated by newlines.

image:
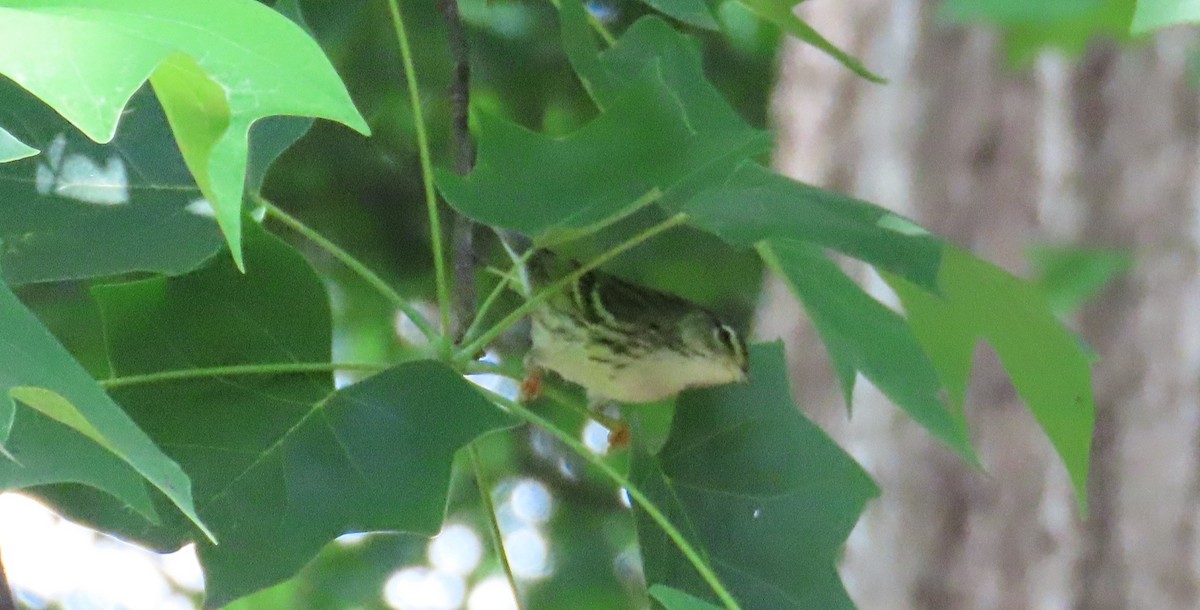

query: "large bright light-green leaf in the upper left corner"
xmin=0 ymin=0 xmax=370 ymax=265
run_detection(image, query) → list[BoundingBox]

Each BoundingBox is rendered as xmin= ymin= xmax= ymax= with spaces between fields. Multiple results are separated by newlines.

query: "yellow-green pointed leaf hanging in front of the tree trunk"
xmin=884 ymin=246 xmax=1096 ymax=514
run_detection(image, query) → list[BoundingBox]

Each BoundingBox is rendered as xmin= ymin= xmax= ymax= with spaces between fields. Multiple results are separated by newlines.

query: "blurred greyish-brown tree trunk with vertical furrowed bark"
xmin=760 ymin=0 xmax=1200 ymax=610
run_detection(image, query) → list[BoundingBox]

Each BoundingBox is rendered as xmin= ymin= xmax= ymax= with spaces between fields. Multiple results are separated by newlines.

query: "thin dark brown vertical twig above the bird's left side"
xmin=440 ymin=0 xmax=475 ymax=340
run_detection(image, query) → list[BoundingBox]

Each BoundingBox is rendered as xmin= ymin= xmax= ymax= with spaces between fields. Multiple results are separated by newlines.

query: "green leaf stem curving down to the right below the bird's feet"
xmin=482 ymin=393 xmax=742 ymax=610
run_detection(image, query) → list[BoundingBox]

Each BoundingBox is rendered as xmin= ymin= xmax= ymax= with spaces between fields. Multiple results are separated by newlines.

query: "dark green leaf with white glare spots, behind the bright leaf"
xmin=0 ymin=76 xmax=308 ymax=285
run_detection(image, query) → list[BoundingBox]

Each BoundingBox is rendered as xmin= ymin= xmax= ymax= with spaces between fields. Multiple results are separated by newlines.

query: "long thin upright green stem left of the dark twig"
xmin=388 ymin=0 xmax=454 ymax=361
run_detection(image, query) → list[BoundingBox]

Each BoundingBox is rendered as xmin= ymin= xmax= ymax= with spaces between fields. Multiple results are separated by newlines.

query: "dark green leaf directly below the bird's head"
xmin=631 ymin=343 xmax=878 ymax=610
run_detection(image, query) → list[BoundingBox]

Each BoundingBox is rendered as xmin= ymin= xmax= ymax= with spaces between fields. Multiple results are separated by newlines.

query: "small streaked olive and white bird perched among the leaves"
xmin=522 ymin=250 xmax=749 ymax=407
